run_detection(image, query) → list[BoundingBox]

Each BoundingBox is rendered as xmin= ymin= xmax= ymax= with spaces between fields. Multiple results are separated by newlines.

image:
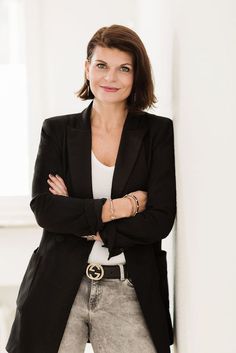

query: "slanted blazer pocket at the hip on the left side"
xmin=16 ymin=248 xmax=41 ymax=309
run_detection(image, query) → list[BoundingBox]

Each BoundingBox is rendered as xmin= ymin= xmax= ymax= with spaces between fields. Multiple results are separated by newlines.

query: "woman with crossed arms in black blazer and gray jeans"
xmin=7 ymin=25 xmax=176 ymax=353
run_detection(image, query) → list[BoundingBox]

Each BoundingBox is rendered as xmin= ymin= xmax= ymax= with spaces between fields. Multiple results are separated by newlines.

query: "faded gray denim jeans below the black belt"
xmin=58 ymin=276 xmax=156 ymax=353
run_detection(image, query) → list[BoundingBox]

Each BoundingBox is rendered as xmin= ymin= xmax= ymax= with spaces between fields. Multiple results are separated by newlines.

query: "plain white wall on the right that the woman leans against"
xmin=172 ymin=0 xmax=236 ymax=353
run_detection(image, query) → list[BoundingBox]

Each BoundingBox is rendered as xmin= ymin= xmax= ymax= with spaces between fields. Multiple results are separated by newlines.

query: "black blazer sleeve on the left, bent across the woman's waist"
xmin=30 ymin=119 xmax=106 ymax=236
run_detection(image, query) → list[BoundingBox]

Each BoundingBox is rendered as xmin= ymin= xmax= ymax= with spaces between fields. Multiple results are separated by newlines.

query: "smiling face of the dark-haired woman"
xmin=85 ymin=46 xmax=134 ymax=104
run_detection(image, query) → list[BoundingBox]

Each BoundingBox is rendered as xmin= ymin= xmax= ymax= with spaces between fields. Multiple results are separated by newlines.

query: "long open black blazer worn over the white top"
xmin=7 ymin=103 xmax=176 ymax=353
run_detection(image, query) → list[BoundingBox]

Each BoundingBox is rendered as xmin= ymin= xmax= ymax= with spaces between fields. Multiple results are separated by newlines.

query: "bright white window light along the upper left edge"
xmin=0 ymin=0 xmax=29 ymax=196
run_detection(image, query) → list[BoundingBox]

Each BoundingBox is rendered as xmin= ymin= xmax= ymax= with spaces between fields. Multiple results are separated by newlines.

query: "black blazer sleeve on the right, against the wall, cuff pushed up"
xmin=100 ymin=118 xmax=176 ymax=258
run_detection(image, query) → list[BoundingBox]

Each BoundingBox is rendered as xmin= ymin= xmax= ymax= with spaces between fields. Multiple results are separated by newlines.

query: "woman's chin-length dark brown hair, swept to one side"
xmin=76 ymin=25 xmax=157 ymax=110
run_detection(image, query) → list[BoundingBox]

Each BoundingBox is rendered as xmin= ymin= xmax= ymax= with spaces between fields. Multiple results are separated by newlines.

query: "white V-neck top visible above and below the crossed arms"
xmin=88 ymin=151 xmax=126 ymax=265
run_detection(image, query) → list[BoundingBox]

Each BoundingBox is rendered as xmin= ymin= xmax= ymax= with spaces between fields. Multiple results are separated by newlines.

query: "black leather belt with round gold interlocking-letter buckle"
xmin=86 ymin=263 xmax=128 ymax=281
